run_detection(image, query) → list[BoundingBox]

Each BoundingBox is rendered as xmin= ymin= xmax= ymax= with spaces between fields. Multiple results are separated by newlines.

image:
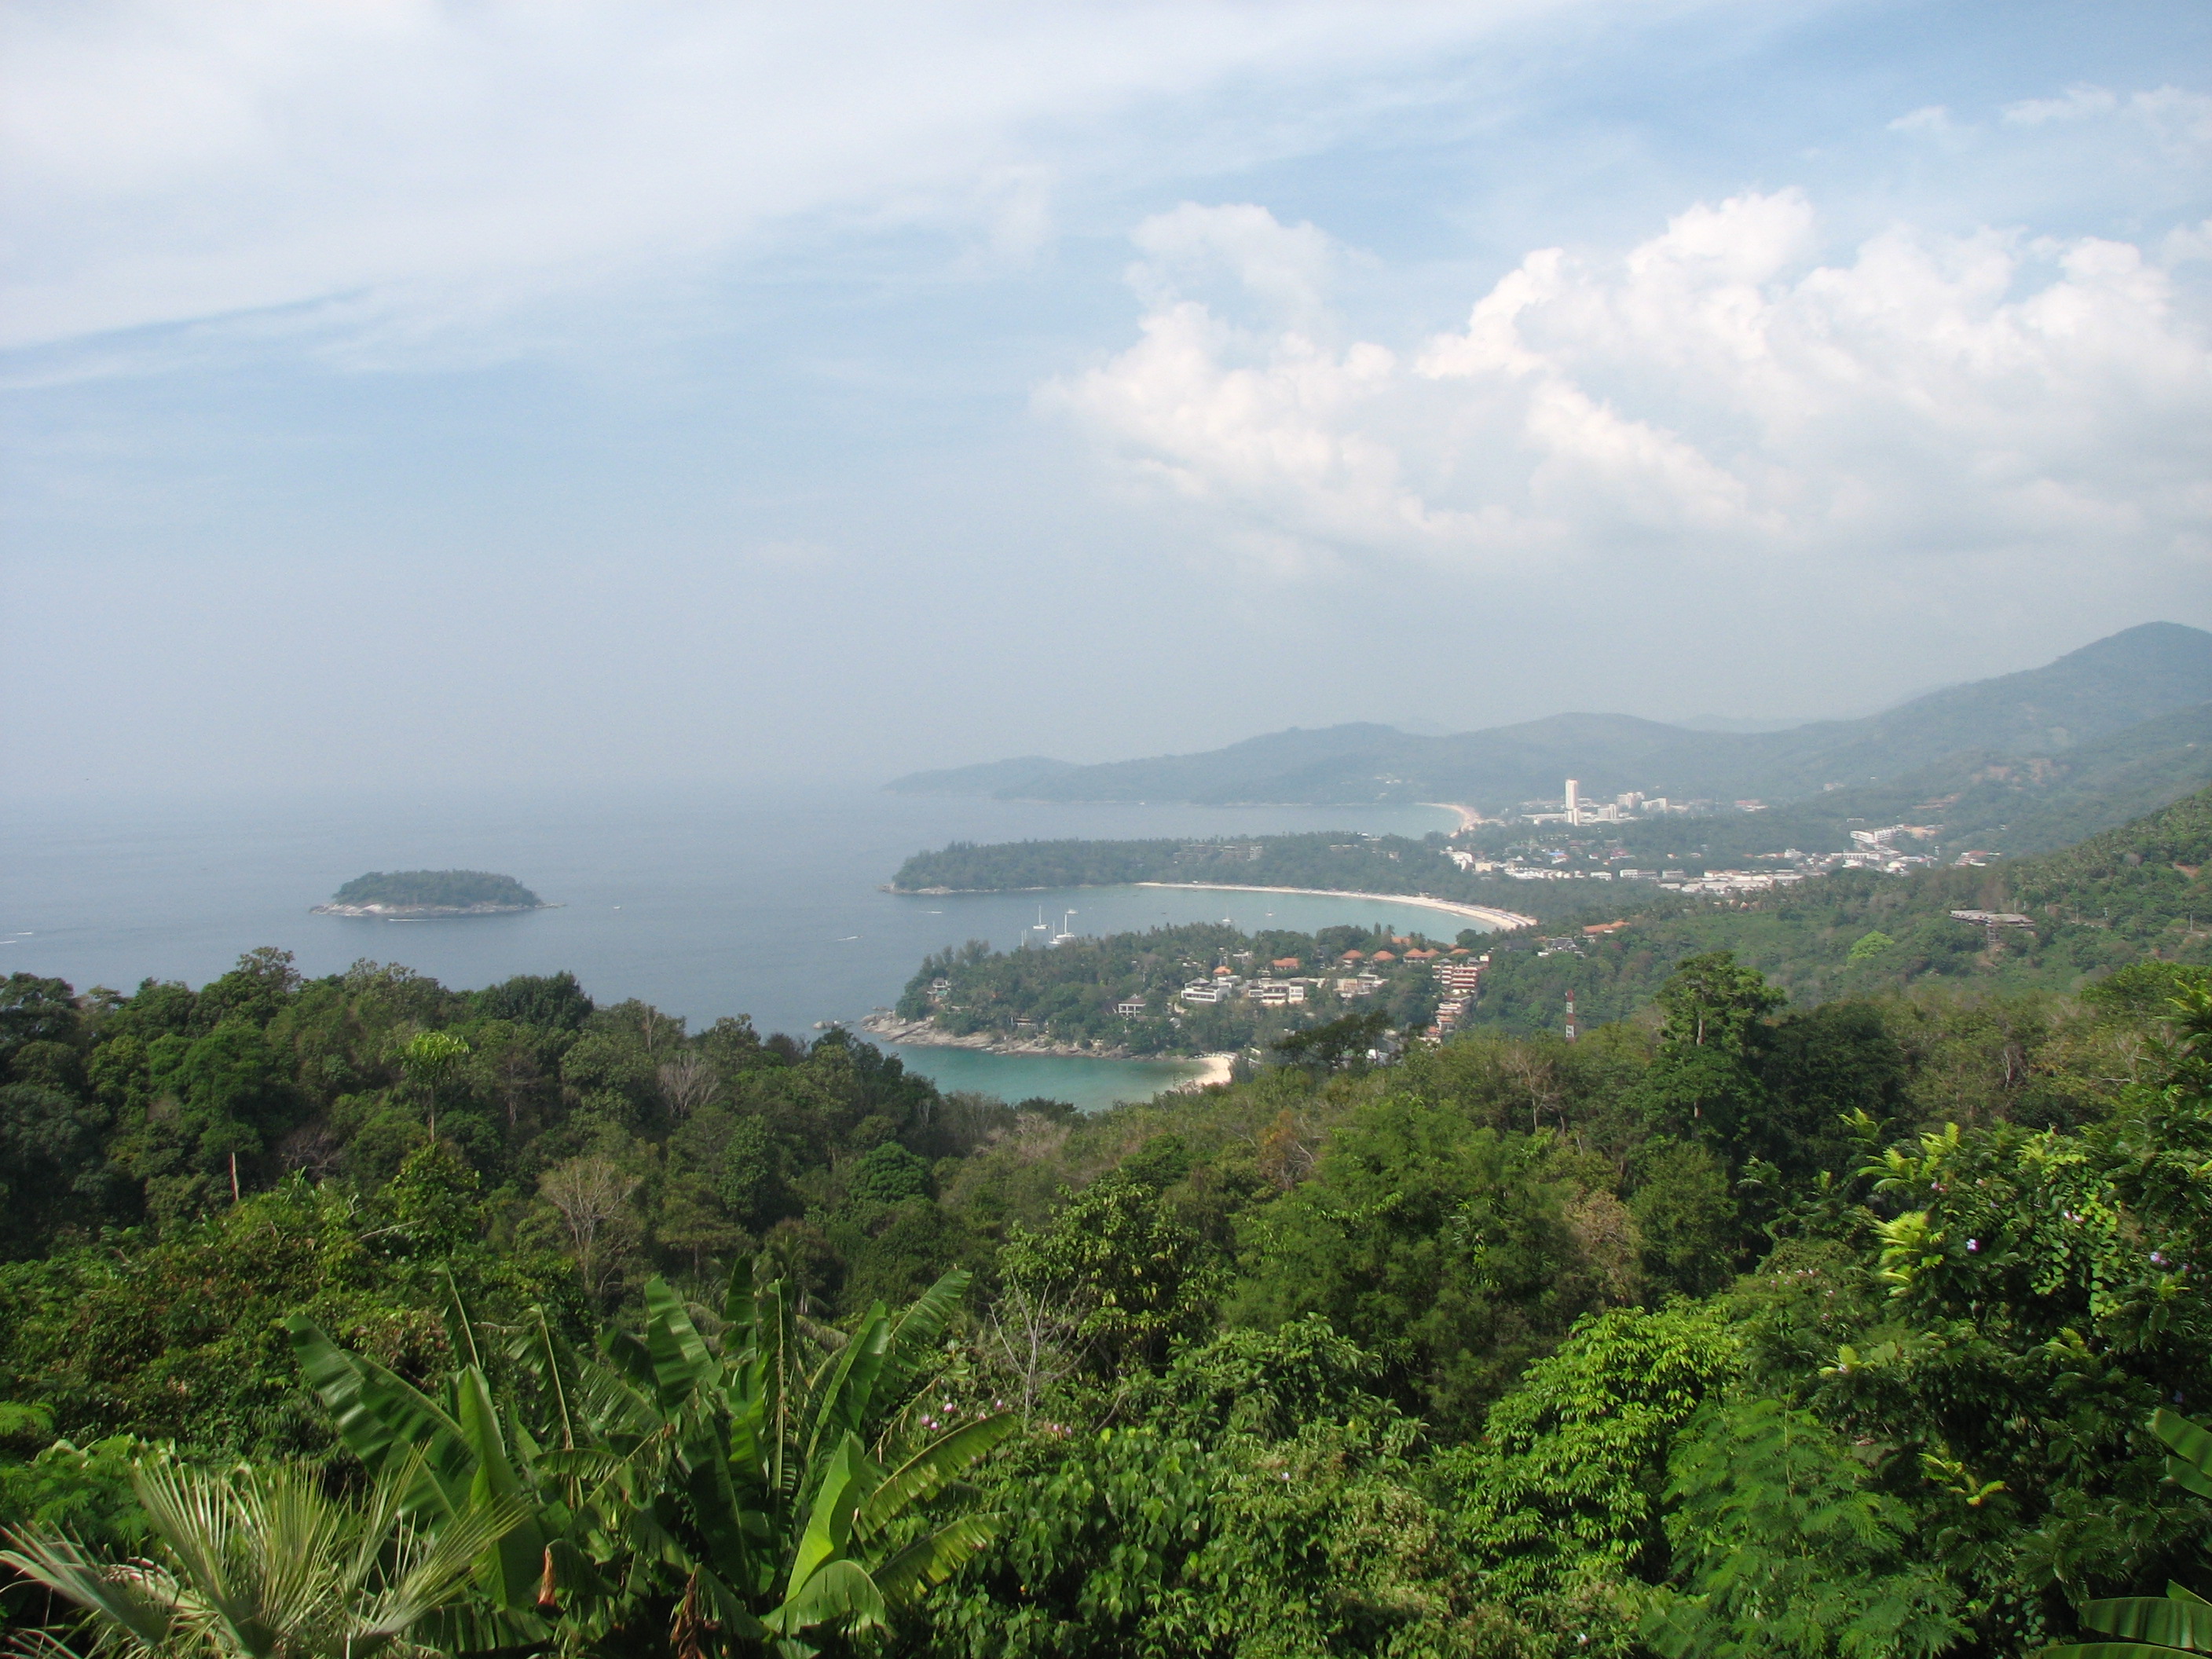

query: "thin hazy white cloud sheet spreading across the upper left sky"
xmin=0 ymin=0 xmax=1604 ymax=345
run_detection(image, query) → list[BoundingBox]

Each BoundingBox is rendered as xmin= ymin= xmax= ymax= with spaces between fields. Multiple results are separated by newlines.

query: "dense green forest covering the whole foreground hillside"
xmin=0 ymin=799 xmax=2212 ymax=1659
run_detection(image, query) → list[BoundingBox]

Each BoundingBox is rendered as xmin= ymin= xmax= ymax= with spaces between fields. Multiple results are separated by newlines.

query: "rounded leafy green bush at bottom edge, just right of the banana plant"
xmin=920 ymin=1318 xmax=1469 ymax=1659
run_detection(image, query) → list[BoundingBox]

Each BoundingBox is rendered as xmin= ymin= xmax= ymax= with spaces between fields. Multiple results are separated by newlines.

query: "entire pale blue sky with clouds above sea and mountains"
xmin=0 ymin=0 xmax=2212 ymax=799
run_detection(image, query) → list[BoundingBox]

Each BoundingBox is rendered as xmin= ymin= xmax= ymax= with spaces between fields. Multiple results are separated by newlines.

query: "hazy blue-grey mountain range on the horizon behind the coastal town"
xmin=889 ymin=621 xmax=2212 ymax=845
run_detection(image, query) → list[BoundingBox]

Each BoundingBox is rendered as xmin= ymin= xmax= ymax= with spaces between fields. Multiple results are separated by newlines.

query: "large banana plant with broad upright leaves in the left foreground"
xmin=292 ymin=1263 xmax=1016 ymax=1659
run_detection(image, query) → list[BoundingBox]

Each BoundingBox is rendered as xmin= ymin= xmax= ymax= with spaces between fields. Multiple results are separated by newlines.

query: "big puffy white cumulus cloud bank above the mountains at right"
xmin=1042 ymin=190 xmax=2212 ymax=582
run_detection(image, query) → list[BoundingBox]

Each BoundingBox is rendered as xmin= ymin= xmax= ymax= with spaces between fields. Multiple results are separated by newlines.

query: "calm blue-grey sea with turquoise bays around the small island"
xmin=0 ymin=786 xmax=1467 ymax=1111
